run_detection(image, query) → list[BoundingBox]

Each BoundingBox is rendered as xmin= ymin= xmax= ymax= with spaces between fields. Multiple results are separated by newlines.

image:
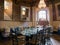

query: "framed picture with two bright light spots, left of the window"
xmin=20 ymin=6 xmax=30 ymax=21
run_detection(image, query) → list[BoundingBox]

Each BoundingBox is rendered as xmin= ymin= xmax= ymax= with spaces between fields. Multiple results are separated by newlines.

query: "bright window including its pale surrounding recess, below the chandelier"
xmin=37 ymin=9 xmax=49 ymax=21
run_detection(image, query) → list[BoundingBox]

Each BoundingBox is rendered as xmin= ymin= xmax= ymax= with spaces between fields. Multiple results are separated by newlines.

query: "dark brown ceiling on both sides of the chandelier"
xmin=14 ymin=0 xmax=53 ymax=6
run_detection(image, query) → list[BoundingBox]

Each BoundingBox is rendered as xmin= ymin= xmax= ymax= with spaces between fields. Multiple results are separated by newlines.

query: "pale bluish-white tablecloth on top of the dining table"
xmin=21 ymin=28 xmax=43 ymax=36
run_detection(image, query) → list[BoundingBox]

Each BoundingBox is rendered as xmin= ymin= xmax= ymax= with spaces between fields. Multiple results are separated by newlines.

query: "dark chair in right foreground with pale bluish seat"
xmin=44 ymin=27 xmax=53 ymax=45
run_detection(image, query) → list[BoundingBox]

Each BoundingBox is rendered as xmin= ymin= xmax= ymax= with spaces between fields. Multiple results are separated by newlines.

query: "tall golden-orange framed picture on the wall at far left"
xmin=4 ymin=0 xmax=12 ymax=21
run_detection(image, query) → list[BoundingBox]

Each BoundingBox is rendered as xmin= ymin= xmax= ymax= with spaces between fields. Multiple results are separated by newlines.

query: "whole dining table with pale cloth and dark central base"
xmin=21 ymin=27 xmax=43 ymax=45
